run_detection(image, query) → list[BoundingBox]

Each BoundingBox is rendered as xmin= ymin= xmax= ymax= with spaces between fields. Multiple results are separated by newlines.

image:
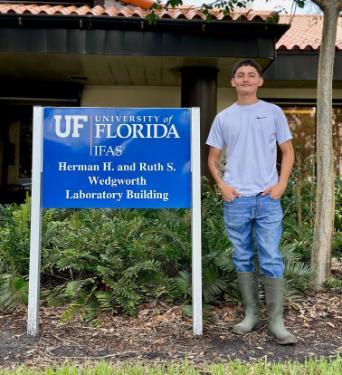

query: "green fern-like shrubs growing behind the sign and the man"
xmin=0 ymin=178 xmax=341 ymax=320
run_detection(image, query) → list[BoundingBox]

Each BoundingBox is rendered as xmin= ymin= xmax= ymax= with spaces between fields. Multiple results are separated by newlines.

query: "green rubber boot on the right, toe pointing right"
xmin=264 ymin=277 xmax=297 ymax=345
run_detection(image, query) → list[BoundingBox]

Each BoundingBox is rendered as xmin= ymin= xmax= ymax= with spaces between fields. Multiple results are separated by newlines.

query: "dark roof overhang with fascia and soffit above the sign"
xmin=0 ymin=14 xmax=289 ymax=86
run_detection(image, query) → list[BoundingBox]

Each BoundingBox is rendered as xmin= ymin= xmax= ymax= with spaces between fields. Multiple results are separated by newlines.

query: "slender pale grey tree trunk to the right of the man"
xmin=311 ymin=0 xmax=342 ymax=289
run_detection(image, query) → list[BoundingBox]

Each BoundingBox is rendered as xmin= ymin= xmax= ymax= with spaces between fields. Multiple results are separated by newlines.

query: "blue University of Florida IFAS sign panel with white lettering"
xmin=42 ymin=108 xmax=191 ymax=208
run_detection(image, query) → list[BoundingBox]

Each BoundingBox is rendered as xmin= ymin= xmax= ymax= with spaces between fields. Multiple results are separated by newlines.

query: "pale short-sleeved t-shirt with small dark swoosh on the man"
xmin=207 ymin=100 xmax=292 ymax=196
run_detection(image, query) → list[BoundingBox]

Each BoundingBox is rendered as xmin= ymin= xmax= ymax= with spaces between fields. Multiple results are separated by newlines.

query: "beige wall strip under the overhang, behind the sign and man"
xmin=81 ymin=86 xmax=342 ymax=111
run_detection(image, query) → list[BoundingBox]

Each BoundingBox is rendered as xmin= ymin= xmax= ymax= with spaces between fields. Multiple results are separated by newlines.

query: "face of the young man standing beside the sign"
xmin=231 ymin=66 xmax=264 ymax=95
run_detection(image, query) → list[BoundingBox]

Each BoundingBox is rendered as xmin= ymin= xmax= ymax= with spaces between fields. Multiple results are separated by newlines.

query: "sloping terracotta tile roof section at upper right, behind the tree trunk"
xmin=277 ymin=15 xmax=342 ymax=50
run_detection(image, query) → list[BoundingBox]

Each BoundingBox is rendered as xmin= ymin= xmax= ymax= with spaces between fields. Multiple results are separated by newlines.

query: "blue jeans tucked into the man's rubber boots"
xmin=223 ymin=194 xmax=284 ymax=278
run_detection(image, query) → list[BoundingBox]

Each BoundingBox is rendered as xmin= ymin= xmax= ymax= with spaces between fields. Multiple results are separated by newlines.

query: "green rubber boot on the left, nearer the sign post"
xmin=233 ymin=272 xmax=261 ymax=335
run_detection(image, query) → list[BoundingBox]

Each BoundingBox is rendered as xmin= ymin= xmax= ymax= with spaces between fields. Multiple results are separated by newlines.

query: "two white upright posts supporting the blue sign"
xmin=27 ymin=107 xmax=203 ymax=337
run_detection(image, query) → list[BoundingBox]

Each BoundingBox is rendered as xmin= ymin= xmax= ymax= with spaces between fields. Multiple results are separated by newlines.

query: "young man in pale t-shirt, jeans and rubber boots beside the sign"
xmin=207 ymin=60 xmax=297 ymax=345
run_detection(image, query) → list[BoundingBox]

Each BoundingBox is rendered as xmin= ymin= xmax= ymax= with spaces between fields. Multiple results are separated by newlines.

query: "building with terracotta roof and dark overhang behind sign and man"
xmin=0 ymin=0 xmax=342 ymax=203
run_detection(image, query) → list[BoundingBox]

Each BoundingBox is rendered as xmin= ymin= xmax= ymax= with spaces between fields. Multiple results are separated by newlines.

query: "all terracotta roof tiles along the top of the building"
xmin=0 ymin=0 xmax=342 ymax=50
